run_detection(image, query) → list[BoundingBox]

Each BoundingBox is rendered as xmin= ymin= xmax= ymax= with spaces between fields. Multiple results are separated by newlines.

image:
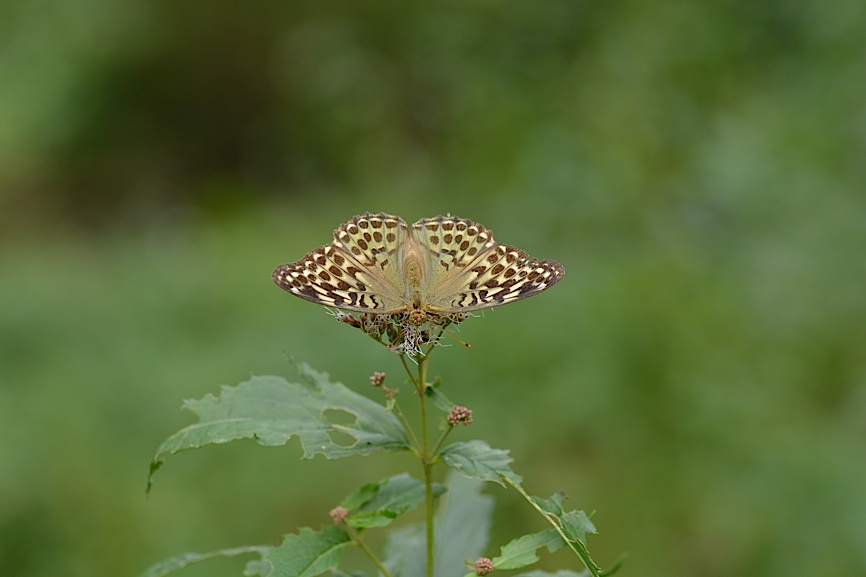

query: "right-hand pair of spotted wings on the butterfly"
xmin=412 ymin=216 xmax=564 ymax=314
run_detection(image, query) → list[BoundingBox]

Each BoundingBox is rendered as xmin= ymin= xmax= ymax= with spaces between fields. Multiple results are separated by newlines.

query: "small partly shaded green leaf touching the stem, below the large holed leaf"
xmin=343 ymin=473 xmax=445 ymax=529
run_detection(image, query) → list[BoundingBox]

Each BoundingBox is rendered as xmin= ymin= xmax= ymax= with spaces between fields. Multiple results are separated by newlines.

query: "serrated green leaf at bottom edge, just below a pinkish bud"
xmin=244 ymin=526 xmax=352 ymax=577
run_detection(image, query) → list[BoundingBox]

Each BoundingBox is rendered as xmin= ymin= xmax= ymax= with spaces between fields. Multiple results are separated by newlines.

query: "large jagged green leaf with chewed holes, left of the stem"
xmin=148 ymin=364 xmax=410 ymax=489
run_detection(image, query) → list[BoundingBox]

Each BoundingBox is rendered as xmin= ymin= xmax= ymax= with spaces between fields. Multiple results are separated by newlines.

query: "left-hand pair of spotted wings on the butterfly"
xmin=272 ymin=212 xmax=408 ymax=314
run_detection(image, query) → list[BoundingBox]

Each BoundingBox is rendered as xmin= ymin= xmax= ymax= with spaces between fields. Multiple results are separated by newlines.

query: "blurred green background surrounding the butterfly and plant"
xmin=0 ymin=0 xmax=866 ymax=577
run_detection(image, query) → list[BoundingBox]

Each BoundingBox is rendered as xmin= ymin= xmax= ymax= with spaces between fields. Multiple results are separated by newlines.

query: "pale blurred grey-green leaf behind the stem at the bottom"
xmin=384 ymin=472 xmax=493 ymax=577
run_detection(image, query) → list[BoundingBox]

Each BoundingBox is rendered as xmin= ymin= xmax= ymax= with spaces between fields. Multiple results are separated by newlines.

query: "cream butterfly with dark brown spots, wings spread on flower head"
xmin=273 ymin=212 xmax=564 ymax=325
